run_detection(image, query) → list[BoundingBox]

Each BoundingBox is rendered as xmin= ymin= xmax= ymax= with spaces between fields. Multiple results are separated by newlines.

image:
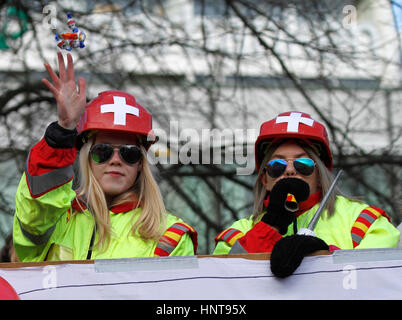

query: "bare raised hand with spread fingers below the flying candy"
xmin=42 ymin=52 xmax=86 ymax=130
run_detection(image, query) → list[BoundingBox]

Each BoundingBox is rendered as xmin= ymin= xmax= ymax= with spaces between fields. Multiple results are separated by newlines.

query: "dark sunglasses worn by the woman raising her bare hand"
xmin=89 ymin=143 xmax=142 ymax=165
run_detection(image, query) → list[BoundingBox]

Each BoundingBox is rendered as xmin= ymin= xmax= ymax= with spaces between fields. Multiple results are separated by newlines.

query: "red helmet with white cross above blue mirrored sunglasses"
xmin=255 ymin=111 xmax=332 ymax=172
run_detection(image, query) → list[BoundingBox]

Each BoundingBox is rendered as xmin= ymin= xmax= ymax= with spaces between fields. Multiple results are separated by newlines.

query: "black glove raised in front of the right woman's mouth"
xmin=261 ymin=178 xmax=310 ymax=234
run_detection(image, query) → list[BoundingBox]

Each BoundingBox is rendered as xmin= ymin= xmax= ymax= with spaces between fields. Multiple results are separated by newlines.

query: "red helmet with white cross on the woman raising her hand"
xmin=76 ymin=90 xmax=155 ymax=150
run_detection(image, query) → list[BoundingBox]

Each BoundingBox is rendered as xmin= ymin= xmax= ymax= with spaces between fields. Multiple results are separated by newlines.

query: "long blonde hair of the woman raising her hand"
xmin=77 ymin=136 xmax=166 ymax=250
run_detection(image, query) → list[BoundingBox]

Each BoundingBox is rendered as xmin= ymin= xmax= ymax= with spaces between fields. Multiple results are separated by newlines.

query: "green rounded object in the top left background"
xmin=0 ymin=6 xmax=28 ymax=50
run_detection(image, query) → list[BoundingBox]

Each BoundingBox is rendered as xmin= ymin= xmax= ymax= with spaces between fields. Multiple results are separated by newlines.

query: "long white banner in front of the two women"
xmin=0 ymin=249 xmax=402 ymax=300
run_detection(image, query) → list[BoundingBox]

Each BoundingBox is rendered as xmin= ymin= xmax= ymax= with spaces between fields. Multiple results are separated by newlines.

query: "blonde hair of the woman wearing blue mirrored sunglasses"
xmin=253 ymin=140 xmax=341 ymax=222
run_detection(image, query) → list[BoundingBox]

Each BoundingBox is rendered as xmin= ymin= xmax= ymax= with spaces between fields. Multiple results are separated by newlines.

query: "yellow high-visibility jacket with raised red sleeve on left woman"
xmin=13 ymin=134 xmax=197 ymax=261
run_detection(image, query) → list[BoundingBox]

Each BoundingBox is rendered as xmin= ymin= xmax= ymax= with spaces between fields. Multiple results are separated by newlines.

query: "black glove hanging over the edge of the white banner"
xmin=271 ymin=234 xmax=329 ymax=278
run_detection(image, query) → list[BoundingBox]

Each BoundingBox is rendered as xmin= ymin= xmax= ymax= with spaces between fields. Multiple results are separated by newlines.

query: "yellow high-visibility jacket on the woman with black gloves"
xmin=214 ymin=196 xmax=400 ymax=254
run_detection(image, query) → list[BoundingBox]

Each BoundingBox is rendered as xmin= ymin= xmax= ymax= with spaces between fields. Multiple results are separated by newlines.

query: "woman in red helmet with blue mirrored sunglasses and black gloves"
xmin=214 ymin=112 xmax=399 ymax=277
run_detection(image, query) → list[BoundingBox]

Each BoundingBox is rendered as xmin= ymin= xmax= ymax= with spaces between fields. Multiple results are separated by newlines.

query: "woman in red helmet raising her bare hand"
xmin=13 ymin=53 xmax=197 ymax=261
